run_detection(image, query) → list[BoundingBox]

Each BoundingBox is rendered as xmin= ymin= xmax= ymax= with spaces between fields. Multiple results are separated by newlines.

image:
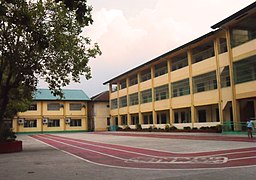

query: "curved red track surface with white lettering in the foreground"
xmin=32 ymin=134 xmax=256 ymax=169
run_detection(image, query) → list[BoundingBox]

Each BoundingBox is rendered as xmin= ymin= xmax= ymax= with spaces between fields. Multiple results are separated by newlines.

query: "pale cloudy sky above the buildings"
xmin=39 ymin=0 xmax=255 ymax=97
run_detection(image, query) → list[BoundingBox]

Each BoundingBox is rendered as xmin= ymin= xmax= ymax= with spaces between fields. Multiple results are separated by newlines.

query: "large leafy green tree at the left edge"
xmin=0 ymin=0 xmax=101 ymax=129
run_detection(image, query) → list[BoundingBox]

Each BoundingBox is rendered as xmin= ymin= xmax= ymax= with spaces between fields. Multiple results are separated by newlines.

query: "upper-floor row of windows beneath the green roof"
xmin=28 ymin=103 xmax=85 ymax=111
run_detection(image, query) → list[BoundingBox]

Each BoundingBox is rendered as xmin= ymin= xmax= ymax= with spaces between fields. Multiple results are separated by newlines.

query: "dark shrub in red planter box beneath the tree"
xmin=0 ymin=126 xmax=22 ymax=153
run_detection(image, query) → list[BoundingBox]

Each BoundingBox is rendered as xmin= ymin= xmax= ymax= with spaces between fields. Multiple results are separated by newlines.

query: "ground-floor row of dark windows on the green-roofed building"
xmin=24 ymin=119 xmax=82 ymax=128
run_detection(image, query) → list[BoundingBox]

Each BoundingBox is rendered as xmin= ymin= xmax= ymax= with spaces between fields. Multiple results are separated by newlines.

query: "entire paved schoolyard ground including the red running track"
xmin=0 ymin=133 xmax=256 ymax=180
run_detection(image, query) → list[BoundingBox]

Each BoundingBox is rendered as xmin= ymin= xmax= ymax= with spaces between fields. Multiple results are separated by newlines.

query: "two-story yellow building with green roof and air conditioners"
xmin=12 ymin=89 xmax=90 ymax=133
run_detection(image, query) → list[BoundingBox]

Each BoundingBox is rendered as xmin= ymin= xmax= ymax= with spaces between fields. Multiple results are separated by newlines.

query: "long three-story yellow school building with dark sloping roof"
xmin=103 ymin=2 xmax=256 ymax=131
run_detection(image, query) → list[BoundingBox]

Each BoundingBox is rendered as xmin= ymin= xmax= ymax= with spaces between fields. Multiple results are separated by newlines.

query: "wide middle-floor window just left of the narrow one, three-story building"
xmin=193 ymin=71 xmax=217 ymax=93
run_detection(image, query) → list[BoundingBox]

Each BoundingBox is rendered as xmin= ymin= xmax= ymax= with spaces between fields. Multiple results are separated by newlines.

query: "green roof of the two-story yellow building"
xmin=33 ymin=89 xmax=90 ymax=101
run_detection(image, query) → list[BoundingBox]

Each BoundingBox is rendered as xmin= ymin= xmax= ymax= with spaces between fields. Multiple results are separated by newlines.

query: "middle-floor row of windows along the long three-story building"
xmin=111 ymin=56 xmax=256 ymax=109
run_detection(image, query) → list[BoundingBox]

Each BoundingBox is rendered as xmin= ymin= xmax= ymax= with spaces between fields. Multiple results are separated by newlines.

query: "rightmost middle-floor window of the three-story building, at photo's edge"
xmin=233 ymin=56 xmax=256 ymax=84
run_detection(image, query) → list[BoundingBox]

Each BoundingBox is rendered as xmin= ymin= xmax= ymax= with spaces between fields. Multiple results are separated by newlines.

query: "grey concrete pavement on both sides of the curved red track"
xmin=0 ymin=133 xmax=256 ymax=180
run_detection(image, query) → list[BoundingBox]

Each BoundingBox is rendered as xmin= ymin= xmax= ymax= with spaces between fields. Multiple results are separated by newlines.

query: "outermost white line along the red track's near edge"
xmin=29 ymin=136 xmax=256 ymax=171
